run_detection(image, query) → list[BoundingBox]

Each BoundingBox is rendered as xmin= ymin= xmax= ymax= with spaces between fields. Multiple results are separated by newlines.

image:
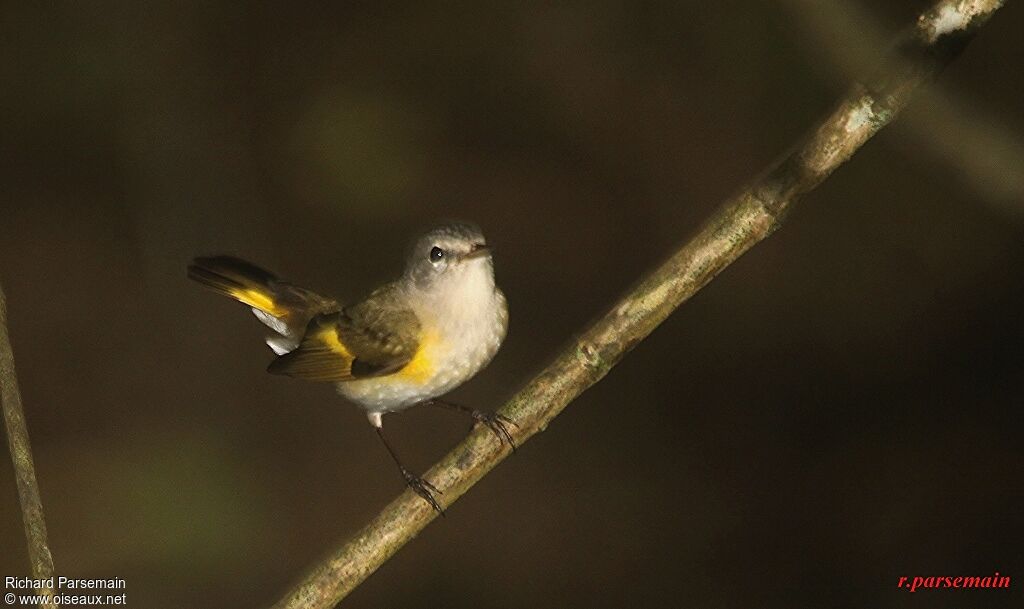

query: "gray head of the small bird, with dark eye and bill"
xmin=406 ymin=222 xmax=494 ymax=290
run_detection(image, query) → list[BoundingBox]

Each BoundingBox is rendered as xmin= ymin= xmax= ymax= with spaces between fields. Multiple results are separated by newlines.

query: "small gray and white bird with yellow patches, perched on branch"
xmin=188 ymin=222 xmax=515 ymax=515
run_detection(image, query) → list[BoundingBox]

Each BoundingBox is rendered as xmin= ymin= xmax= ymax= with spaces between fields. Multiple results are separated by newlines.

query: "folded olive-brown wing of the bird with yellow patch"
xmin=267 ymin=286 xmax=420 ymax=383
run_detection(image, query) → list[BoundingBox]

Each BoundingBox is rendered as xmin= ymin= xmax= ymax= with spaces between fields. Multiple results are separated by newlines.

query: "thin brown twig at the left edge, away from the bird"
xmin=0 ymin=280 xmax=55 ymax=607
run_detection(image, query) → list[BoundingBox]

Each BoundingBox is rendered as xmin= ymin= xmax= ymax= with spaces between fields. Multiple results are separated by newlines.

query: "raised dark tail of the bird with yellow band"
xmin=188 ymin=256 xmax=339 ymax=355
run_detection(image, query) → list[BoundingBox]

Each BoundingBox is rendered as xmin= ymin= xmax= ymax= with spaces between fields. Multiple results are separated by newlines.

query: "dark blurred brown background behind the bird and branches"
xmin=0 ymin=0 xmax=1024 ymax=609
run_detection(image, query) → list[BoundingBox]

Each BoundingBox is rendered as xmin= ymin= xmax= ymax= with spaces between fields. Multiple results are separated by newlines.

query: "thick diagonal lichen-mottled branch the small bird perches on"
xmin=274 ymin=0 xmax=1002 ymax=609
